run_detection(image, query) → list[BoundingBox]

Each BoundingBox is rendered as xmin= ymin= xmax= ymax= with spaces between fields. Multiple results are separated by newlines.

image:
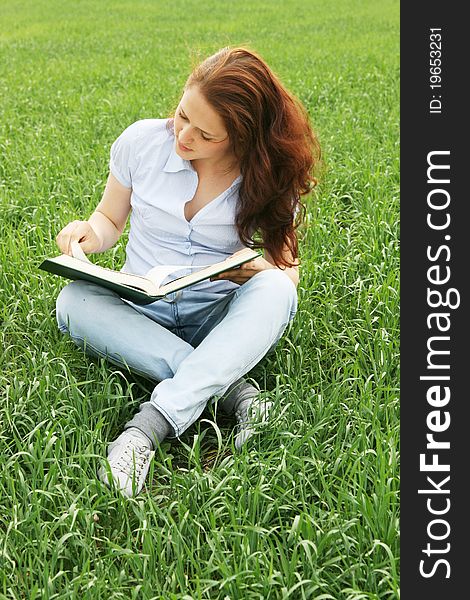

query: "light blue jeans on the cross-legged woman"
xmin=56 ymin=269 xmax=297 ymax=437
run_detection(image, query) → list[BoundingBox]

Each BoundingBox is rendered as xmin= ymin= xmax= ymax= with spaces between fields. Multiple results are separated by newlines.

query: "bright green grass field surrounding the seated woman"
xmin=0 ymin=0 xmax=399 ymax=600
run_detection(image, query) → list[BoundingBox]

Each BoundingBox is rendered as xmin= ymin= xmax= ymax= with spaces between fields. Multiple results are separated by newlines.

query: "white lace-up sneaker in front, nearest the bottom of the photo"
xmin=98 ymin=427 xmax=155 ymax=498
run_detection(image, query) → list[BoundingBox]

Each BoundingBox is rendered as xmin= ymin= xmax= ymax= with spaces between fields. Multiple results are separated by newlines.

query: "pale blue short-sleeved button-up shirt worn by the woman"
xmin=110 ymin=119 xmax=244 ymax=293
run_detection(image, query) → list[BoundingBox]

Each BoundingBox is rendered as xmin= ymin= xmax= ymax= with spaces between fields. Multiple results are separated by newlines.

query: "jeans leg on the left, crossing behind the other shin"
xmin=56 ymin=281 xmax=193 ymax=381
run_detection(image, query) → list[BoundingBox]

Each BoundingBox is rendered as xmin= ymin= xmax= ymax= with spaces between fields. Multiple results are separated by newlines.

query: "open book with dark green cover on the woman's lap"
xmin=39 ymin=242 xmax=261 ymax=304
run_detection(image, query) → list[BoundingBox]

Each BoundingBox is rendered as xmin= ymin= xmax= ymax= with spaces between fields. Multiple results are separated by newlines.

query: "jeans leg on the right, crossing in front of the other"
xmin=150 ymin=269 xmax=297 ymax=436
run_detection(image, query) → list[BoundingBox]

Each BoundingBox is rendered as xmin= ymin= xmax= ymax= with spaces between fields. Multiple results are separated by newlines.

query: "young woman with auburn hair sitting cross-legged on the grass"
xmin=57 ymin=48 xmax=318 ymax=496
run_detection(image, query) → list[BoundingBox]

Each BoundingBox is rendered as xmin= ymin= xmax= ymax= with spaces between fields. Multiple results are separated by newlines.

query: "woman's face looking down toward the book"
xmin=174 ymin=85 xmax=237 ymax=165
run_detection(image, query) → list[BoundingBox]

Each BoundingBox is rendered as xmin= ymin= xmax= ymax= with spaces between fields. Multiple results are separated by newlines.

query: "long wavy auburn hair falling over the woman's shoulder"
xmin=169 ymin=47 xmax=320 ymax=267
